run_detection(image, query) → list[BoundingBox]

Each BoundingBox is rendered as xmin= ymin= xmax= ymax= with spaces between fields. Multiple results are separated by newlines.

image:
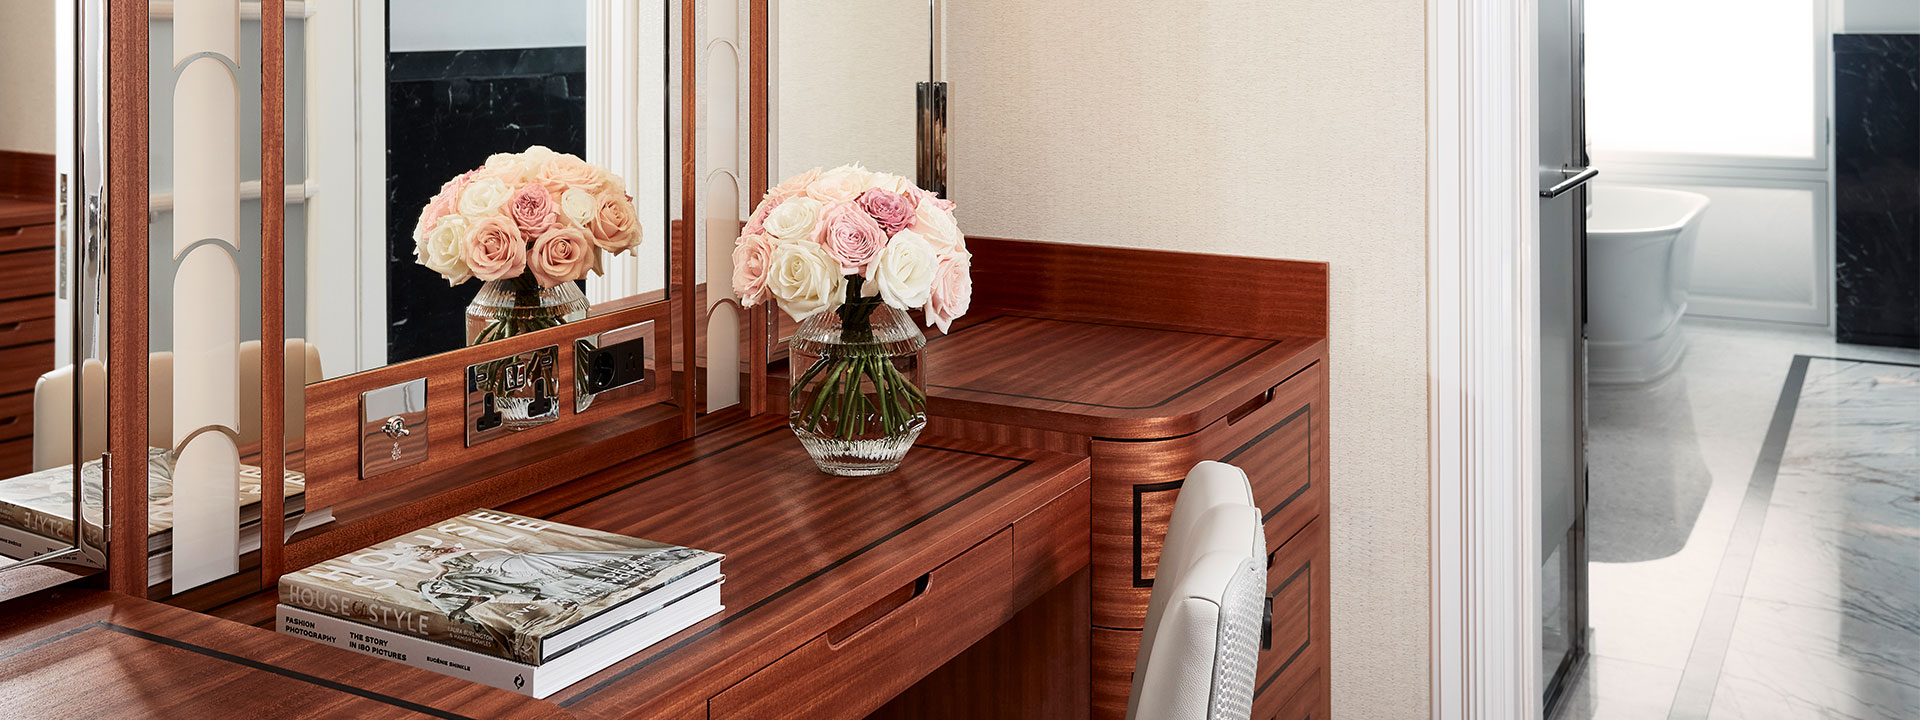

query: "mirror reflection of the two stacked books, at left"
xmin=0 ymin=447 xmax=334 ymax=586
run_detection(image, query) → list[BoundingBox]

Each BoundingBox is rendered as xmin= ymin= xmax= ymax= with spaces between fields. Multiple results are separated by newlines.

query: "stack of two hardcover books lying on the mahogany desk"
xmin=276 ymin=511 xmax=724 ymax=697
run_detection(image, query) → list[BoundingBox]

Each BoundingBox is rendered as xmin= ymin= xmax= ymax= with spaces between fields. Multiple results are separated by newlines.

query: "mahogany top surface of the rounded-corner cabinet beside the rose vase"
xmin=925 ymin=315 xmax=1325 ymax=440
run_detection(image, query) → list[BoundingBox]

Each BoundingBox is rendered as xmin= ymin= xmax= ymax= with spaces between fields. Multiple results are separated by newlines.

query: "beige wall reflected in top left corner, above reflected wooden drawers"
xmin=0 ymin=0 xmax=56 ymax=152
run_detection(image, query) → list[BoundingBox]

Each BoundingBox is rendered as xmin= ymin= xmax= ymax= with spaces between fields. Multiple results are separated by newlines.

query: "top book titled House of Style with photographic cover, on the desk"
xmin=280 ymin=509 xmax=722 ymax=664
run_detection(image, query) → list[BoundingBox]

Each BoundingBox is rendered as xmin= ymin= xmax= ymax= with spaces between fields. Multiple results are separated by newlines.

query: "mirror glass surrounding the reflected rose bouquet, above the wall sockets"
xmin=286 ymin=0 xmax=670 ymax=378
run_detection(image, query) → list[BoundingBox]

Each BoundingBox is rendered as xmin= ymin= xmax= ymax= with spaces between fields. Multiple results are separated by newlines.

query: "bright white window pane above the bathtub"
xmin=1586 ymin=0 xmax=1822 ymax=157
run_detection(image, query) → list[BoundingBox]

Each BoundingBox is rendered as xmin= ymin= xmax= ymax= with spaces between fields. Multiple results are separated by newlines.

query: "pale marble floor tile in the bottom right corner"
xmin=1707 ymin=597 xmax=1920 ymax=720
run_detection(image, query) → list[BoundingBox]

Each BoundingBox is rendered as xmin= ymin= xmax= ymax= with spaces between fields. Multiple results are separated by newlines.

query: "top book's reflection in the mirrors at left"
xmin=0 ymin=447 xmax=307 ymax=543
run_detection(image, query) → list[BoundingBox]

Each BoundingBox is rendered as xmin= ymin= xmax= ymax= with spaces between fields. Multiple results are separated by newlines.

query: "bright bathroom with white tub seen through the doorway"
xmin=1542 ymin=0 xmax=1920 ymax=718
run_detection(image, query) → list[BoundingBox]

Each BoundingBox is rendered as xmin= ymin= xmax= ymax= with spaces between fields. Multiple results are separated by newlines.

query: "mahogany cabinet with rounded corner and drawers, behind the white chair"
xmin=927 ymin=315 xmax=1331 ymax=718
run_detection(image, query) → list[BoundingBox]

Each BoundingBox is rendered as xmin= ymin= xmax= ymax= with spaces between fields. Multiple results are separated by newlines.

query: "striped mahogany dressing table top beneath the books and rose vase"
xmin=505 ymin=417 xmax=1087 ymax=718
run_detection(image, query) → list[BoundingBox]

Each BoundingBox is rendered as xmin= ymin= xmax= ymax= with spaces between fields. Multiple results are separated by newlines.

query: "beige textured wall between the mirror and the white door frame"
xmin=947 ymin=0 xmax=1428 ymax=718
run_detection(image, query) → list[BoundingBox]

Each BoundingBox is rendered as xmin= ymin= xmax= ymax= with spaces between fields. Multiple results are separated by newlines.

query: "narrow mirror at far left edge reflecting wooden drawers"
xmin=0 ymin=2 xmax=106 ymax=593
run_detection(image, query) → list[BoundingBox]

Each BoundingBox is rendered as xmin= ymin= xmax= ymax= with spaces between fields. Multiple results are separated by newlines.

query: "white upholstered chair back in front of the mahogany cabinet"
xmin=1127 ymin=463 xmax=1267 ymax=720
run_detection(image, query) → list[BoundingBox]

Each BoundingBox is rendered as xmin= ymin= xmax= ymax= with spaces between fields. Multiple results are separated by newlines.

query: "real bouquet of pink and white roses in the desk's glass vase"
xmin=733 ymin=165 xmax=973 ymax=332
